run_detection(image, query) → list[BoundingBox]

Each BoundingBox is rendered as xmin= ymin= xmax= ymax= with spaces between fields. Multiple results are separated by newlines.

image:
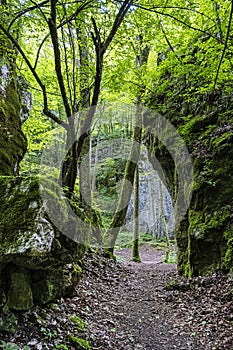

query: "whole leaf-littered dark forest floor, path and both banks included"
xmin=0 ymin=246 xmax=233 ymax=350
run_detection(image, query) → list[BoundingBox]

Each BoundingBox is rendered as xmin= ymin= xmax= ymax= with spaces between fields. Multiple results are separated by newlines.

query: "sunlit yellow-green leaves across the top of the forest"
xmin=0 ymin=0 xmax=233 ymax=175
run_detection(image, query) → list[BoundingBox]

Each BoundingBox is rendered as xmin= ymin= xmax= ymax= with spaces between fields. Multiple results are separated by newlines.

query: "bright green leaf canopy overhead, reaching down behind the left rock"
xmin=4 ymin=0 xmax=232 ymax=183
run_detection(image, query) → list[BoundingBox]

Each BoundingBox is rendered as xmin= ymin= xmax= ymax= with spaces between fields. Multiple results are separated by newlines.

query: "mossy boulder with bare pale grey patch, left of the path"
xmin=0 ymin=176 xmax=88 ymax=310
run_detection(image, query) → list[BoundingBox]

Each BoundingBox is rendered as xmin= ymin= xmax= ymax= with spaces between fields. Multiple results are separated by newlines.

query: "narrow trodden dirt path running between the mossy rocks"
xmin=92 ymin=247 xmax=193 ymax=350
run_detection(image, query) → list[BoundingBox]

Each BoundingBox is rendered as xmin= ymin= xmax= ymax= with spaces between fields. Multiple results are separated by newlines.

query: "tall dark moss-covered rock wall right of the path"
xmin=145 ymin=69 xmax=233 ymax=276
